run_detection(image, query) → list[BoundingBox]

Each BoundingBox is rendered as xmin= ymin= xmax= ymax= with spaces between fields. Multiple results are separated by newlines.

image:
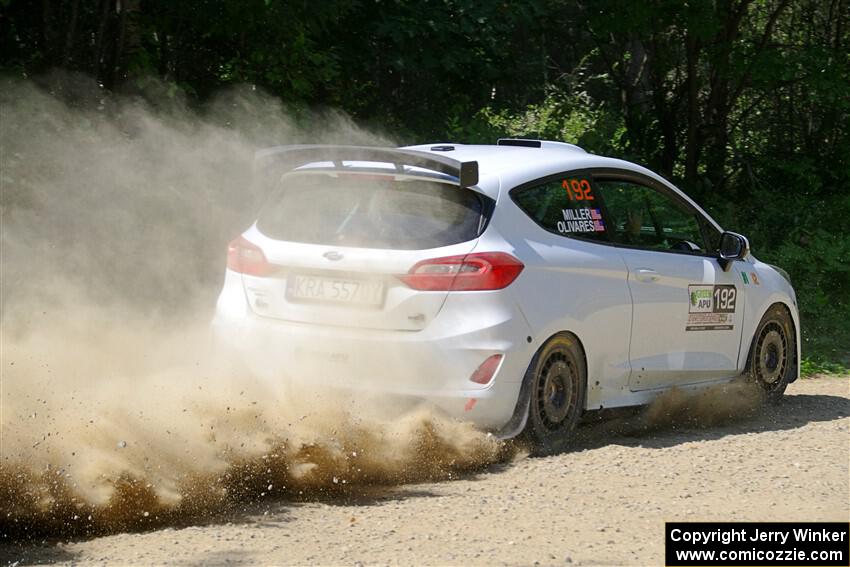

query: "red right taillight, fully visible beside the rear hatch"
xmin=398 ymin=252 xmax=525 ymax=291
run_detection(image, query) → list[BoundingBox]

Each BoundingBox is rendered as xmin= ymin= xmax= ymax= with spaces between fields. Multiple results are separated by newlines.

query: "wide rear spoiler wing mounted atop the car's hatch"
xmin=254 ymin=145 xmax=478 ymax=187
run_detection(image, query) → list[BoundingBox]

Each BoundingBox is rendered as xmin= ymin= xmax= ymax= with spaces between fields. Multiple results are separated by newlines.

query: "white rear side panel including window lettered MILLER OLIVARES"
xmin=506 ymin=171 xmax=632 ymax=407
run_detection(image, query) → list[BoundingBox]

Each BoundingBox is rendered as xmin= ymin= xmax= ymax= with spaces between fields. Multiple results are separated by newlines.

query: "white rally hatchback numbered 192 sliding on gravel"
xmin=214 ymin=139 xmax=800 ymax=448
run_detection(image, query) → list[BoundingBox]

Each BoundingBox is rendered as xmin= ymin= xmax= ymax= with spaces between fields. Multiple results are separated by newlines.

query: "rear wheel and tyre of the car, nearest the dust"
xmin=523 ymin=334 xmax=587 ymax=455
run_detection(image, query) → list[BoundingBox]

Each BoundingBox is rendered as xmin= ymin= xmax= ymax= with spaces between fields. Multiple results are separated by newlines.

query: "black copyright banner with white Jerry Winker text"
xmin=664 ymin=522 xmax=850 ymax=567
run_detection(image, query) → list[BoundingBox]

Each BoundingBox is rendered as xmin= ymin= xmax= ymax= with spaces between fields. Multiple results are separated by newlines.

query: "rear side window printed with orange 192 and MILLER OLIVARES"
xmin=511 ymin=175 xmax=609 ymax=242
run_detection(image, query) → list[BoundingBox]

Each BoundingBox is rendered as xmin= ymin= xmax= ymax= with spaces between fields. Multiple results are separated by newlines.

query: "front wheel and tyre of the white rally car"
xmin=747 ymin=305 xmax=797 ymax=403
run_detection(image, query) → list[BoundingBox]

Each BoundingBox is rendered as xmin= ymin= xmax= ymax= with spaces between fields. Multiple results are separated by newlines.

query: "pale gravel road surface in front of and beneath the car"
xmin=0 ymin=377 xmax=850 ymax=565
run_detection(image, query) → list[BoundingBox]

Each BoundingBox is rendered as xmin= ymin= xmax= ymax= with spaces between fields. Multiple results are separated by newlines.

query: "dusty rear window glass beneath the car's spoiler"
xmin=257 ymin=174 xmax=485 ymax=250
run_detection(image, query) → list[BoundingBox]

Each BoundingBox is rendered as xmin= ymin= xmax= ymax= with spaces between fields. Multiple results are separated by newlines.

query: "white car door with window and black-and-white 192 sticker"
xmin=594 ymin=172 xmax=745 ymax=391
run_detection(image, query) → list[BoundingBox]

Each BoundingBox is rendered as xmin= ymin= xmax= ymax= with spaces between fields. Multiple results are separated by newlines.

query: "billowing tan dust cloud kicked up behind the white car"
xmin=0 ymin=76 xmax=502 ymax=543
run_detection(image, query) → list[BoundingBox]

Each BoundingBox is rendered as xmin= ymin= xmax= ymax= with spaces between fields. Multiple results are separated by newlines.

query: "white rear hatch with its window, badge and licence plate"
xmin=232 ymin=173 xmax=492 ymax=331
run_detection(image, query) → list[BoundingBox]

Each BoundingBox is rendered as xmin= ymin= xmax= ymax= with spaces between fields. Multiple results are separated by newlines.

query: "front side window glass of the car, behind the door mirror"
xmin=596 ymin=179 xmax=706 ymax=254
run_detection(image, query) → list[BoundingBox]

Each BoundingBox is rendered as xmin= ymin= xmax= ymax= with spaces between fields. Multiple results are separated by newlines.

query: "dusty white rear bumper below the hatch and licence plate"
xmin=212 ymin=286 xmax=533 ymax=430
